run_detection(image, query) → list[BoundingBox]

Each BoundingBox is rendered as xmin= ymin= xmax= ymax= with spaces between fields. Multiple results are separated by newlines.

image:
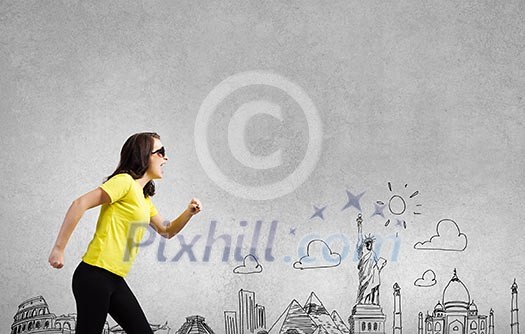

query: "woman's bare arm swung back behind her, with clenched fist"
xmin=48 ymin=188 xmax=111 ymax=269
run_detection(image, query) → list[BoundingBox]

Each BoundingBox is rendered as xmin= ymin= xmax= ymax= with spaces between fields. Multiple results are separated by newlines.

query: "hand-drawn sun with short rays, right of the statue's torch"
xmin=374 ymin=182 xmax=422 ymax=229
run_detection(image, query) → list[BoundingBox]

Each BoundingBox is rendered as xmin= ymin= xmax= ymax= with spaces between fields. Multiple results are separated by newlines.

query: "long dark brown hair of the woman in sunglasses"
xmin=107 ymin=132 xmax=160 ymax=197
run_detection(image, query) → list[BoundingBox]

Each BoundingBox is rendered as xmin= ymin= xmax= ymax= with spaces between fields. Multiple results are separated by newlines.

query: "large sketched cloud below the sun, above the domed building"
xmin=414 ymin=219 xmax=468 ymax=252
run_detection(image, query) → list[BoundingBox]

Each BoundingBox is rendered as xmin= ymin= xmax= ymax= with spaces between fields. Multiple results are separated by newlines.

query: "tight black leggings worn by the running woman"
xmin=73 ymin=262 xmax=153 ymax=334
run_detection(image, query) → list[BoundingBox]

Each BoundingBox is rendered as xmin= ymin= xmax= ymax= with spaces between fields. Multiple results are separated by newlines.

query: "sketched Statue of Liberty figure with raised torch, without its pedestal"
xmin=356 ymin=214 xmax=386 ymax=305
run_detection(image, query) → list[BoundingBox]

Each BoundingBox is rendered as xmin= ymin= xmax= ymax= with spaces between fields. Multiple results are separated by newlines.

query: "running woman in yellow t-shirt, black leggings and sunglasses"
xmin=49 ymin=132 xmax=201 ymax=334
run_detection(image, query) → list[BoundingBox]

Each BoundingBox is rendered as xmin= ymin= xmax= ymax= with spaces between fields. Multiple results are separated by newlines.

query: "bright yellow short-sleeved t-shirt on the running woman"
xmin=82 ymin=173 xmax=157 ymax=277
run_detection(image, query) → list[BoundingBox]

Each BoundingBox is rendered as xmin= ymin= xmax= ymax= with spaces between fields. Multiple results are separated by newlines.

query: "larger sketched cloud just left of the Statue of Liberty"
xmin=293 ymin=239 xmax=341 ymax=270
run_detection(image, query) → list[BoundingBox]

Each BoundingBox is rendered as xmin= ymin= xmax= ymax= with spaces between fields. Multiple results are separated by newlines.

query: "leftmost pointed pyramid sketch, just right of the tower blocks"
xmin=268 ymin=299 xmax=317 ymax=334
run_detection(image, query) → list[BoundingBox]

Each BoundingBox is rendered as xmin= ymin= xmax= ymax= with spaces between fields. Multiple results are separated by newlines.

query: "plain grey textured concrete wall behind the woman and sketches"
xmin=0 ymin=0 xmax=525 ymax=333
